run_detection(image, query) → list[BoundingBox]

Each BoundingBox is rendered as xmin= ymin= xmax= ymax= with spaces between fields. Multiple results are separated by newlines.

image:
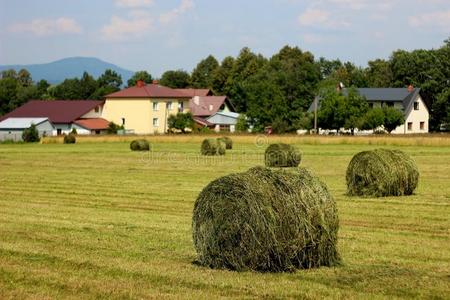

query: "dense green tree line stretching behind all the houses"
xmin=0 ymin=39 xmax=450 ymax=133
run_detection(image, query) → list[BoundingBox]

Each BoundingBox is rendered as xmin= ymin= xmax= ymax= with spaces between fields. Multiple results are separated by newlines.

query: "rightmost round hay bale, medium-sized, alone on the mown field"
xmin=346 ymin=149 xmax=419 ymax=197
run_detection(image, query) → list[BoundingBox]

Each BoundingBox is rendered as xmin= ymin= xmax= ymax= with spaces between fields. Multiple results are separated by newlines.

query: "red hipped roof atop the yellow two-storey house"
xmin=105 ymin=83 xmax=189 ymax=98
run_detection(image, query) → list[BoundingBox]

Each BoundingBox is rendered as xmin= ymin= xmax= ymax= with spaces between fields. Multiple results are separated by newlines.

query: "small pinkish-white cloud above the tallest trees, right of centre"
xmin=298 ymin=8 xmax=350 ymax=28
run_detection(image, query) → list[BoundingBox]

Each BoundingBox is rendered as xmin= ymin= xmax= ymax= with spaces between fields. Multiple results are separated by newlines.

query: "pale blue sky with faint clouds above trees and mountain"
xmin=0 ymin=0 xmax=450 ymax=76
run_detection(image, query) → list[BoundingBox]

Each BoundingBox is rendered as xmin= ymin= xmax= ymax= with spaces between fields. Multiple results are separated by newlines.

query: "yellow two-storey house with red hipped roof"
xmin=102 ymin=81 xmax=191 ymax=134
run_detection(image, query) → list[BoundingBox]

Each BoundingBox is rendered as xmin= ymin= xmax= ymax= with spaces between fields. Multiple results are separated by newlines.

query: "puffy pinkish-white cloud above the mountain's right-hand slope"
xmin=101 ymin=13 xmax=153 ymax=41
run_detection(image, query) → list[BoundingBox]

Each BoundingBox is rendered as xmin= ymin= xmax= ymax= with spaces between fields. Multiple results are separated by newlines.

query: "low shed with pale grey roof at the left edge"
xmin=0 ymin=118 xmax=55 ymax=142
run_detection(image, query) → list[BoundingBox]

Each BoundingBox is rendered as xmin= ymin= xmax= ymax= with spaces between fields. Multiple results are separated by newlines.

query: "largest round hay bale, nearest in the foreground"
xmin=192 ymin=167 xmax=340 ymax=272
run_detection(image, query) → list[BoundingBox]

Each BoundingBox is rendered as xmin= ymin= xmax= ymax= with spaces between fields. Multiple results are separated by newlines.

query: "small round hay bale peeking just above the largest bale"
xmin=264 ymin=143 xmax=302 ymax=168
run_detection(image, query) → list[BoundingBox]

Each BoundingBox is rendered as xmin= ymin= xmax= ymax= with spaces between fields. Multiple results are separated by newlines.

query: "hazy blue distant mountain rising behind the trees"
xmin=0 ymin=57 xmax=134 ymax=84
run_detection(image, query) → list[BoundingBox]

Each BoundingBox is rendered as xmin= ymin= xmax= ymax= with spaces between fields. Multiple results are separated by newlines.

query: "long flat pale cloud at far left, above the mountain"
xmin=9 ymin=17 xmax=82 ymax=36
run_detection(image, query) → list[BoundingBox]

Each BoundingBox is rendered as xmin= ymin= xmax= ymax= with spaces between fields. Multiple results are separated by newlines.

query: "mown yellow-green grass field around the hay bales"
xmin=0 ymin=137 xmax=450 ymax=299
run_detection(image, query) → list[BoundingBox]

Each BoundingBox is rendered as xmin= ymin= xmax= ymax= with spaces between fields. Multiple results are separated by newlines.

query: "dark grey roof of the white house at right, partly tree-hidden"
xmin=308 ymin=88 xmax=420 ymax=112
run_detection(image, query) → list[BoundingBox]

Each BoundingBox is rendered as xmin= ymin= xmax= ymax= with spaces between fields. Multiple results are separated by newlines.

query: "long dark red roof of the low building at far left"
xmin=0 ymin=100 xmax=104 ymax=124
